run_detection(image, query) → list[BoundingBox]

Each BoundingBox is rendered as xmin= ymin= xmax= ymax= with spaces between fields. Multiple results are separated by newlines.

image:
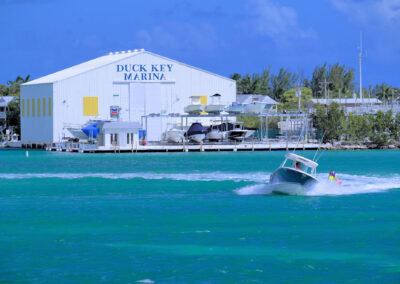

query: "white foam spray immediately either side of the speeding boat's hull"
xmin=235 ymin=173 xmax=400 ymax=196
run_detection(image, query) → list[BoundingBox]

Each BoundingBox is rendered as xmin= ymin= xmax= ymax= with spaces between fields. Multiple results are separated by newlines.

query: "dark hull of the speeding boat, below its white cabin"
xmin=270 ymin=168 xmax=318 ymax=195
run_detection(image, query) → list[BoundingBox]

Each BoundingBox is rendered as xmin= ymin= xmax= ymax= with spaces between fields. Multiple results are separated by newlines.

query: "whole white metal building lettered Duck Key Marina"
xmin=21 ymin=49 xmax=236 ymax=144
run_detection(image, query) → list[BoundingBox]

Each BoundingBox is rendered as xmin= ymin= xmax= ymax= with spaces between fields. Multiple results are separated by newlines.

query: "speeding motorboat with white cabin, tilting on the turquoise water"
xmin=269 ymin=153 xmax=318 ymax=195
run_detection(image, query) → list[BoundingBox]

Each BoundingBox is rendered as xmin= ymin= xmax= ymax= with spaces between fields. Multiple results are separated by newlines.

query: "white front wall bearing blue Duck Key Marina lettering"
xmin=54 ymin=53 xmax=236 ymax=141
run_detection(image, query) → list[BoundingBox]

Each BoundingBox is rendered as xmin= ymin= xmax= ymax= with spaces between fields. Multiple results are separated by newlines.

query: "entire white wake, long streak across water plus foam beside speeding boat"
xmin=0 ymin=172 xmax=400 ymax=196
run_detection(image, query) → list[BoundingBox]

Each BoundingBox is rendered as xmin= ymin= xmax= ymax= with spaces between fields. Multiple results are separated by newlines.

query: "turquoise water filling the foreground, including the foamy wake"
xmin=0 ymin=151 xmax=400 ymax=283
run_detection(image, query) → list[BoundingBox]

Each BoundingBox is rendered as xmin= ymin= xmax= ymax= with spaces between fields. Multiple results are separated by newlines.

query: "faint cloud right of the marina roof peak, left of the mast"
xmin=247 ymin=0 xmax=316 ymax=41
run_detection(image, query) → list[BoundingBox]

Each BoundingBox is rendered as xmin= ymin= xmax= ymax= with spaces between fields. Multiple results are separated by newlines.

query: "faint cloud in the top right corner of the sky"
xmin=330 ymin=0 xmax=400 ymax=25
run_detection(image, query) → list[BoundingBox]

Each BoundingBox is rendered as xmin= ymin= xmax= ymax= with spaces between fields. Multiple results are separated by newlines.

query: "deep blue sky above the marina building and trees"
xmin=0 ymin=0 xmax=400 ymax=87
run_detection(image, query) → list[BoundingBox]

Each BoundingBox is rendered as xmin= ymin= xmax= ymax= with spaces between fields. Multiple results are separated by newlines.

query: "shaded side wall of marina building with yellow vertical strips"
xmin=20 ymin=84 xmax=56 ymax=144
